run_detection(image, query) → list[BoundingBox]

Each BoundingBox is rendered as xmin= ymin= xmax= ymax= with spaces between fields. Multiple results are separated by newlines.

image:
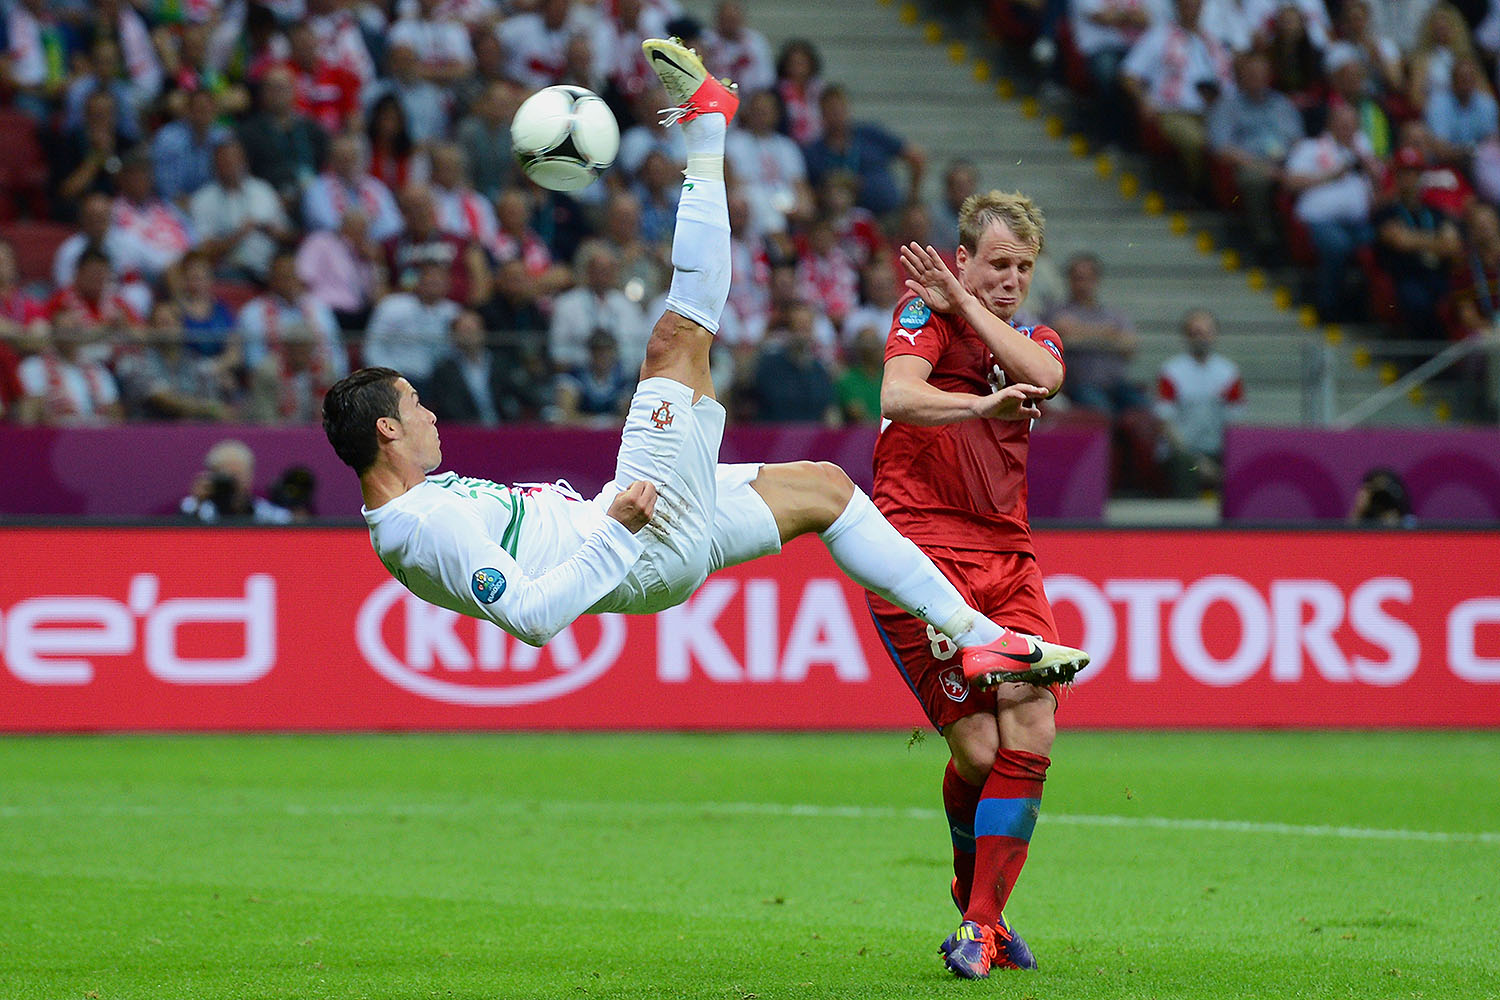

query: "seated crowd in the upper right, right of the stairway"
xmin=989 ymin=0 xmax=1500 ymax=367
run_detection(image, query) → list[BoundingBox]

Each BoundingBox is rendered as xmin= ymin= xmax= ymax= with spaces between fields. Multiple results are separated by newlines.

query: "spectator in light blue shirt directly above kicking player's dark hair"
xmin=365 ymin=259 xmax=462 ymax=391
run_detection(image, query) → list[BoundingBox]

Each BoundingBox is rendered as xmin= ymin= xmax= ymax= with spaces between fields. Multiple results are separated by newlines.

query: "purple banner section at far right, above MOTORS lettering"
xmin=1224 ymin=427 xmax=1500 ymax=523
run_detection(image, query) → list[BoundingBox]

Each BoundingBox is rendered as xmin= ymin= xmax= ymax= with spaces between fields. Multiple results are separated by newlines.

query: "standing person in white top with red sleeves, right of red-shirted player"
xmin=1157 ymin=309 xmax=1245 ymax=493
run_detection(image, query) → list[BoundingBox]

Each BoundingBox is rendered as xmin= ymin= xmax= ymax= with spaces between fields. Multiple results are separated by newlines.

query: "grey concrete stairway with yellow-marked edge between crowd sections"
xmin=687 ymin=0 xmax=1434 ymax=424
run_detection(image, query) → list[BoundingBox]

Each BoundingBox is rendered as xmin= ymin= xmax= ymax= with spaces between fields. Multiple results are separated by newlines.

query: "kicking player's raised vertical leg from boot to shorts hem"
xmin=641 ymin=39 xmax=740 ymax=396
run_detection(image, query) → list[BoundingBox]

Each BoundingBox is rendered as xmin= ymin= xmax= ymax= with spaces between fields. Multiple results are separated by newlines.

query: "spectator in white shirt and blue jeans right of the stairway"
xmin=1286 ymin=103 xmax=1382 ymax=321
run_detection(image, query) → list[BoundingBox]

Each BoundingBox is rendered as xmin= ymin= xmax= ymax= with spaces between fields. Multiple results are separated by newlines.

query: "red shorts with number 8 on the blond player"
xmin=866 ymin=546 xmax=1058 ymax=730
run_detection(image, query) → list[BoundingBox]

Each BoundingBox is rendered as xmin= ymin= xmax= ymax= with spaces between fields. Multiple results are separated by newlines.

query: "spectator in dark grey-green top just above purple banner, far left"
xmin=116 ymin=300 xmax=231 ymax=420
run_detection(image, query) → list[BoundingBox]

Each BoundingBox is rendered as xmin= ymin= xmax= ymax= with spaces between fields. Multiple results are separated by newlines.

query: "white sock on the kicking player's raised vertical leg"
xmin=666 ymin=148 xmax=731 ymax=333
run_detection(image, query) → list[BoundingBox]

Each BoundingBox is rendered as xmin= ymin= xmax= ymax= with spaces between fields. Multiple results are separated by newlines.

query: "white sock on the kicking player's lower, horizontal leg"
xmin=819 ymin=487 xmax=1004 ymax=648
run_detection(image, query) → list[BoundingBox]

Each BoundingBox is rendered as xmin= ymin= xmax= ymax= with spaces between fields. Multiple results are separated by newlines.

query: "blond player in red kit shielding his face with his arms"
xmin=870 ymin=190 xmax=1088 ymax=979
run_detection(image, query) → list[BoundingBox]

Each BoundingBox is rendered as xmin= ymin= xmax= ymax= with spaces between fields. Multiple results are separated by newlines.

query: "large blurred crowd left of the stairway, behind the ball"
xmin=0 ymin=0 xmax=948 ymax=426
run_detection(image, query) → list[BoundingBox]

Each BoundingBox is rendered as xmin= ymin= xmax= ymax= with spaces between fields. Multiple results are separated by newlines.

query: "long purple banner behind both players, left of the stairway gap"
xmin=0 ymin=423 xmax=1110 ymax=520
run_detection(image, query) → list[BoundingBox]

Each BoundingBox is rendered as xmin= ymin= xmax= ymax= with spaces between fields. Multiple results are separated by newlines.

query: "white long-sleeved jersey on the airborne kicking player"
xmin=362 ymin=472 xmax=644 ymax=645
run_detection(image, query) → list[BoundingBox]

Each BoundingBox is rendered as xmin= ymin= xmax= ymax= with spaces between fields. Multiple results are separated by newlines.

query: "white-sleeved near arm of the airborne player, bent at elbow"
xmin=428 ymin=517 xmax=644 ymax=646
